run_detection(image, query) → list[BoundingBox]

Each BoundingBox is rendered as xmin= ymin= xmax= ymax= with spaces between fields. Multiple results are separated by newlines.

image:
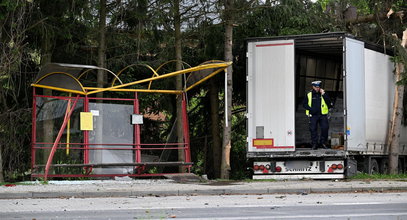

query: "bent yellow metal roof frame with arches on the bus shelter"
xmin=32 ymin=60 xmax=232 ymax=95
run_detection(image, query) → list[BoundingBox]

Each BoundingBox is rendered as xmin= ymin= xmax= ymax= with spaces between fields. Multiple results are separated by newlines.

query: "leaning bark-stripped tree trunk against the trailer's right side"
xmin=388 ymin=29 xmax=407 ymax=174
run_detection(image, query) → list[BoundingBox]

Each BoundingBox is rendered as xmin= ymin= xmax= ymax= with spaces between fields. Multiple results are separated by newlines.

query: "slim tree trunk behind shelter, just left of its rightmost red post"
xmin=174 ymin=0 xmax=185 ymax=173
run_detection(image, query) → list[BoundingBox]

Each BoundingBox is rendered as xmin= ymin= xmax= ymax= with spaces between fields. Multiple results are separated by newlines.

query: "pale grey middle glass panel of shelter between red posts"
xmin=89 ymin=103 xmax=134 ymax=174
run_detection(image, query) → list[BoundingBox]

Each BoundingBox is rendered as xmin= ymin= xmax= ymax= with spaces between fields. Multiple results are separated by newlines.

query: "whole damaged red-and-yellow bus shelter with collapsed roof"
xmin=31 ymin=61 xmax=231 ymax=180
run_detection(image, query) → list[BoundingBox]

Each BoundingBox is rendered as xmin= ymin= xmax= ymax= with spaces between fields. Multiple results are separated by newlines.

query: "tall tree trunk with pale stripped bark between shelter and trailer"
xmin=220 ymin=0 xmax=233 ymax=179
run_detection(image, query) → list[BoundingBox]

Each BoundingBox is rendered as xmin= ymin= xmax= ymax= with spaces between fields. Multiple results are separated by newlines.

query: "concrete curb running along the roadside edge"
xmin=0 ymin=186 xmax=407 ymax=199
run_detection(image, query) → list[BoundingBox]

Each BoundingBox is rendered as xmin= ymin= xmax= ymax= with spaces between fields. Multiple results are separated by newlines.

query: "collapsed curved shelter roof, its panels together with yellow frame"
xmin=32 ymin=61 xmax=232 ymax=95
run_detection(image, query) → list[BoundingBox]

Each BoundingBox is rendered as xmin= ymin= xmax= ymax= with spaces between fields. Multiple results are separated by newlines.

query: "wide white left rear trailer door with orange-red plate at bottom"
xmin=247 ymin=40 xmax=295 ymax=152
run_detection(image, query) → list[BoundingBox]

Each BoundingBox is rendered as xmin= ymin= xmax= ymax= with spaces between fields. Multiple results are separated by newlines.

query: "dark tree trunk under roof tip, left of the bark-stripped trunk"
xmin=209 ymin=78 xmax=222 ymax=178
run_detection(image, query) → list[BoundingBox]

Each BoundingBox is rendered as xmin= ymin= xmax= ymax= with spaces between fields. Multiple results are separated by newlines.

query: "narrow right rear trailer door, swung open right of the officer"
xmin=344 ymin=38 xmax=366 ymax=151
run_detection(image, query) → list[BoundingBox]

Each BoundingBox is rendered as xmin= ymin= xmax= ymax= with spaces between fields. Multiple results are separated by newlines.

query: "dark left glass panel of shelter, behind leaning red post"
xmin=34 ymin=96 xmax=83 ymax=165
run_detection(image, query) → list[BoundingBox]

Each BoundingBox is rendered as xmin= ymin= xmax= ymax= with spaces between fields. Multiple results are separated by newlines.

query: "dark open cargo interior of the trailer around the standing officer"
xmin=295 ymin=36 xmax=345 ymax=150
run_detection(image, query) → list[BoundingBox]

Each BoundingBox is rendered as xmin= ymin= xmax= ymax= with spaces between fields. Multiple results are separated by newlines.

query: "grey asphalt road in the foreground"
xmin=0 ymin=192 xmax=407 ymax=220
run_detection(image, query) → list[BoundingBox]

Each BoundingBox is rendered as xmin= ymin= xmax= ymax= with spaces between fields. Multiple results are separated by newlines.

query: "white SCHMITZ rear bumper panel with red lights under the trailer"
xmin=253 ymin=160 xmax=345 ymax=179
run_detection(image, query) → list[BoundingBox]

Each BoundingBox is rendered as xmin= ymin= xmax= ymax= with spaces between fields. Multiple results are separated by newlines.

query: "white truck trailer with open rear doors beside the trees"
xmin=247 ymin=33 xmax=407 ymax=179
